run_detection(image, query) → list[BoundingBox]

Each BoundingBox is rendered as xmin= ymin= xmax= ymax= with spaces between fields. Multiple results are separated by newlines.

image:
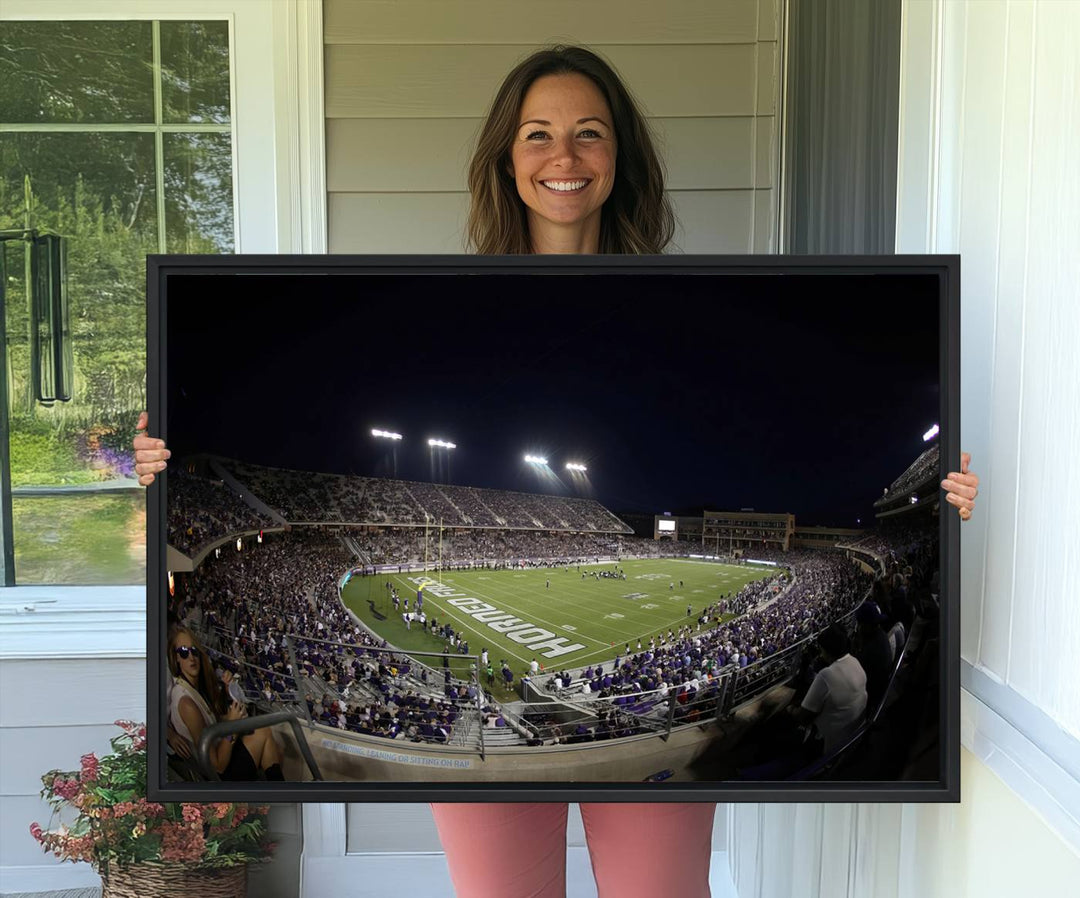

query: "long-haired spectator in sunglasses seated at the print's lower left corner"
xmin=168 ymin=627 xmax=284 ymax=781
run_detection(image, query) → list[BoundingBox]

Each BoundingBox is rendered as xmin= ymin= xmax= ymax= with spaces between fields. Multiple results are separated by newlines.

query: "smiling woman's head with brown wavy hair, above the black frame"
xmin=469 ymin=46 xmax=675 ymax=254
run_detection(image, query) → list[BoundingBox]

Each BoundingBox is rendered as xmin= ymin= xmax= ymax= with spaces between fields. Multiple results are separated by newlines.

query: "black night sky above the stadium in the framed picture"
xmin=164 ymin=272 xmax=940 ymax=526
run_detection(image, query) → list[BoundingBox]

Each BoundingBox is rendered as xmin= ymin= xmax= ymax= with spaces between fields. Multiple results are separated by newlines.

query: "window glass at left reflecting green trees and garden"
xmin=0 ymin=21 xmax=234 ymax=582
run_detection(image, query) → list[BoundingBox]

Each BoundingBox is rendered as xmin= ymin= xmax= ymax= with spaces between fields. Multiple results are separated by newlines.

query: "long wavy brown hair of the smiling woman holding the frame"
xmin=468 ymin=46 xmax=675 ymax=255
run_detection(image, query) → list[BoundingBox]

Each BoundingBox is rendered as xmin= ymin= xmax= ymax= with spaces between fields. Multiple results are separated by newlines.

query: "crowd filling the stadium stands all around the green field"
xmin=170 ymin=453 xmax=935 ymax=756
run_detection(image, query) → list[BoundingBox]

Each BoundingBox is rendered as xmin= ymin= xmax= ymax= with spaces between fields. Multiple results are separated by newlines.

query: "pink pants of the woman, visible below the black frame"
xmin=431 ymin=802 xmax=716 ymax=898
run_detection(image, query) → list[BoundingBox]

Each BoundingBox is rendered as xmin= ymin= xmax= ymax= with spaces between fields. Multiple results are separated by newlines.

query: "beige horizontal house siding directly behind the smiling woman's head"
xmin=324 ymin=0 xmax=780 ymax=253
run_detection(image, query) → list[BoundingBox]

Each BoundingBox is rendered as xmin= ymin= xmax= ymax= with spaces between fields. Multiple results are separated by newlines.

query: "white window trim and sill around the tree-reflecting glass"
xmin=0 ymin=0 xmax=326 ymax=659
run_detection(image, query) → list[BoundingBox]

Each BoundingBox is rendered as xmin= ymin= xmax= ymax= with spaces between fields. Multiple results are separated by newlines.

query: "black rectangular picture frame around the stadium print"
xmin=147 ymin=255 xmax=960 ymax=803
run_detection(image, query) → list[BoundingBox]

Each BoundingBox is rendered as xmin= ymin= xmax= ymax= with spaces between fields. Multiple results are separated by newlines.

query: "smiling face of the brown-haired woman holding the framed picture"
xmin=510 ymin=75 xmax=617 ymax=240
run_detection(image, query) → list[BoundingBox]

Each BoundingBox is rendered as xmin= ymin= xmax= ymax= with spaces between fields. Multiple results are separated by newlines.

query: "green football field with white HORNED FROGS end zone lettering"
xmin=342 ymin=559 xmax=775 ymax=675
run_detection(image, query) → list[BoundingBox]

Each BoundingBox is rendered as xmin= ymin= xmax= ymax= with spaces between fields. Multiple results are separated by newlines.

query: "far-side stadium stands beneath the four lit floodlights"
xmin=168 ymin=463 xmax=694 ymax=565
